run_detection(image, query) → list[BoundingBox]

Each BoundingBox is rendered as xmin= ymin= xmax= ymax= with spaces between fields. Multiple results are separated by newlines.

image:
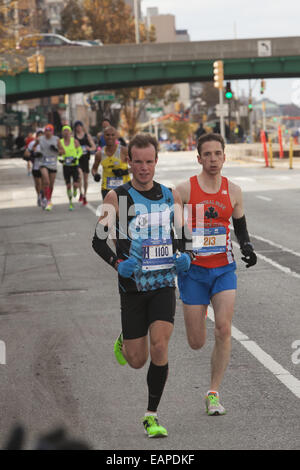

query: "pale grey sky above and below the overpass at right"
xmin=142 ymin=0 xmax=300 ymax=103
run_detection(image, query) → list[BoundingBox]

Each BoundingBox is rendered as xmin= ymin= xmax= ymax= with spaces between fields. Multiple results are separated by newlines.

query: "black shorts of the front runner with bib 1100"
xmin=120 ymin=287 xmax=176 ymax=339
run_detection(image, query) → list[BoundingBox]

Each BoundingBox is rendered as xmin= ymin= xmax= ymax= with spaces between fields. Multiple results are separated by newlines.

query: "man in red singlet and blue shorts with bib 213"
xmin=177 ymin=134 xmax=257 ymax=415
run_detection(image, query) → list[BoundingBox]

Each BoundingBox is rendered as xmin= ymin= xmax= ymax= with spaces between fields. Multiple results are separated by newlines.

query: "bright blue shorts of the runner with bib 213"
xmin=178 ymin=261 xmax=237 ymax=305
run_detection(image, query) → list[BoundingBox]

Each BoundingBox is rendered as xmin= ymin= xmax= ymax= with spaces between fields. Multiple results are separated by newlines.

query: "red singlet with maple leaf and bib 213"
xmin=188 ymin=175 xmax=234 ymax=268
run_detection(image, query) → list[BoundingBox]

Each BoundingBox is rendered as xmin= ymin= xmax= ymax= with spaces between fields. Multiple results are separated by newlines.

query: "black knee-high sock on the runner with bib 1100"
xmin=147 ymin=362 xmax=169 ymax=412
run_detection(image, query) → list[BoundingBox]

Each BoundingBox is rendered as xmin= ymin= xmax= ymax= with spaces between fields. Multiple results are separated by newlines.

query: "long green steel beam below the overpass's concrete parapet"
xmin=0 ymin=56 xmax=300 ymax=102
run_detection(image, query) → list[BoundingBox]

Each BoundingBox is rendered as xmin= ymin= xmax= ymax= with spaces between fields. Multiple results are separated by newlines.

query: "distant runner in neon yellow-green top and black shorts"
xmin=59 ymin=126 xmax=82 ymax=211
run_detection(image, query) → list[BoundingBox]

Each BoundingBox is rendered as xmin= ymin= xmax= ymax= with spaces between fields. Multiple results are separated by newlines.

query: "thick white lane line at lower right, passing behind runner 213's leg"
xmin=207 ymin=306 xmax=300 ymax=398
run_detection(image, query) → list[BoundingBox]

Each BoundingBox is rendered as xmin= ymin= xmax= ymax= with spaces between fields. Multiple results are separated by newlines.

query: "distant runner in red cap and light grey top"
xmin=32 ymin=124 xmax=64 ymax=211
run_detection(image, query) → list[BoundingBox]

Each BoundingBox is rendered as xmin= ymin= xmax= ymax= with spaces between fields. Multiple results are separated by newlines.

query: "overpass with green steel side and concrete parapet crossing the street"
xmin=0 ymin=37 xmax=300 ymax=102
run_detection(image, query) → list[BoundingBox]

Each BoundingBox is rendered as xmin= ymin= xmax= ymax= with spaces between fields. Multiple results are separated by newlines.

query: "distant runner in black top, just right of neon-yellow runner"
xmin=74 ymin=121 xmax=96 ymax=206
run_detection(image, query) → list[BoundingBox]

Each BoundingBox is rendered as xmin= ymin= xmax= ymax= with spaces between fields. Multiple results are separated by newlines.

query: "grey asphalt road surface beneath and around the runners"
xmin=0 ymin=153 xmax=300 ymax=451
